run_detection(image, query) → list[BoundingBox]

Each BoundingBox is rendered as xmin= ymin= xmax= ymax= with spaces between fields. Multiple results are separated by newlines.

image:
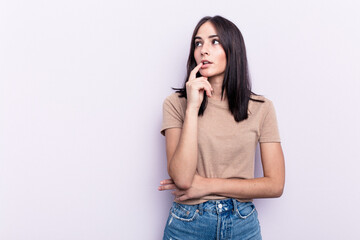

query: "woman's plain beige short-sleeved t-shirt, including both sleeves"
xmin=160 ymin=93 xmax=280 ymax=205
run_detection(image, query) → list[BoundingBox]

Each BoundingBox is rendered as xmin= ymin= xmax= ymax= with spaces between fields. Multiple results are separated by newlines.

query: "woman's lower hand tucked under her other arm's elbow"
xmin=158 ymin=174 xmax=210 ymax=201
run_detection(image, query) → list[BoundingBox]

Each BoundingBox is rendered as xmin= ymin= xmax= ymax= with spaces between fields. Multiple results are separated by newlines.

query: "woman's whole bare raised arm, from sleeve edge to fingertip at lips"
xmin=165 ymin=63 xmax=212 ymax=189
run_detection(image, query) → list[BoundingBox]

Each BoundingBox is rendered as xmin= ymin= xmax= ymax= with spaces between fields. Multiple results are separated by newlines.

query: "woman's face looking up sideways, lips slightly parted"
xmin=194 ymin=22 xmax=226 ymax=80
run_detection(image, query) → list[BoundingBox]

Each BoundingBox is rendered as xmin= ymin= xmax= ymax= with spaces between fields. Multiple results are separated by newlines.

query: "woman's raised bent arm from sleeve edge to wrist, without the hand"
xmin=165 ymin=107 xmax=199 ymax=189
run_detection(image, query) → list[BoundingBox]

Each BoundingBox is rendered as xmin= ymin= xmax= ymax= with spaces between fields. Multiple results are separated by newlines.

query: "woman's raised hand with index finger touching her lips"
xmin=186 ymin=63 xmax=213 ymax=109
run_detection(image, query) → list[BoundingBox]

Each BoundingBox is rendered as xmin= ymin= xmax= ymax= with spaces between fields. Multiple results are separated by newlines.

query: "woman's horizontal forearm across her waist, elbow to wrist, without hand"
xmin=207 ymin=177 xmax=284 ymax=199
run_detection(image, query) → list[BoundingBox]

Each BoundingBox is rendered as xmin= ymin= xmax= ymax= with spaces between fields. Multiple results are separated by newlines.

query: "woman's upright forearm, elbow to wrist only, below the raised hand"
xmin=168 ymin=108 xmax=199 ymax=189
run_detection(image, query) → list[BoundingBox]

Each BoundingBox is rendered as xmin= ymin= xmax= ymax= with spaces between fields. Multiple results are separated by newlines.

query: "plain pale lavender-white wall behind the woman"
xmin=0 ymin=0 xmax=360 ymax=240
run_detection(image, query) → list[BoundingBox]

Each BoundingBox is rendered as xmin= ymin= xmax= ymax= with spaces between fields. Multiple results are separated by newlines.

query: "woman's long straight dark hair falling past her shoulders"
xmin=172 ymin=15 xmax=264 ymax=122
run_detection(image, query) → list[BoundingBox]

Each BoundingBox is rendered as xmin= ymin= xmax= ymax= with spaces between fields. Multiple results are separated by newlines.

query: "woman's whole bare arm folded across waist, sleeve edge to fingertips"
xmin=158 ymin=143 xmax=285 ymax=201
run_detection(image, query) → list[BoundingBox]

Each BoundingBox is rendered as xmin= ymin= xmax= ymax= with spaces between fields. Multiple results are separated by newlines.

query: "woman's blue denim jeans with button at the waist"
xmin=163 ymin=198 xmax=262 ymax=240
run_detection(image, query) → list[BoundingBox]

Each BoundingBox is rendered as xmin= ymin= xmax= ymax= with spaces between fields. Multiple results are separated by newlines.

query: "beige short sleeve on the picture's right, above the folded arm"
xmin=259 ymin=100 xmax=281 ymax=143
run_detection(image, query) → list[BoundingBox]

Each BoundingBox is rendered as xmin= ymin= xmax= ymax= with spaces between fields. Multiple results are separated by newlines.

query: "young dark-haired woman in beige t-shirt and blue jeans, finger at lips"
xmin=159 ymin=16 xmax=285 ymax=240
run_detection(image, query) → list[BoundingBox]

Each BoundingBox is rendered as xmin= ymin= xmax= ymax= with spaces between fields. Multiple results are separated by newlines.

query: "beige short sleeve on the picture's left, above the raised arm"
xmin=160 ymin=94 xmax=184 ymax=136
